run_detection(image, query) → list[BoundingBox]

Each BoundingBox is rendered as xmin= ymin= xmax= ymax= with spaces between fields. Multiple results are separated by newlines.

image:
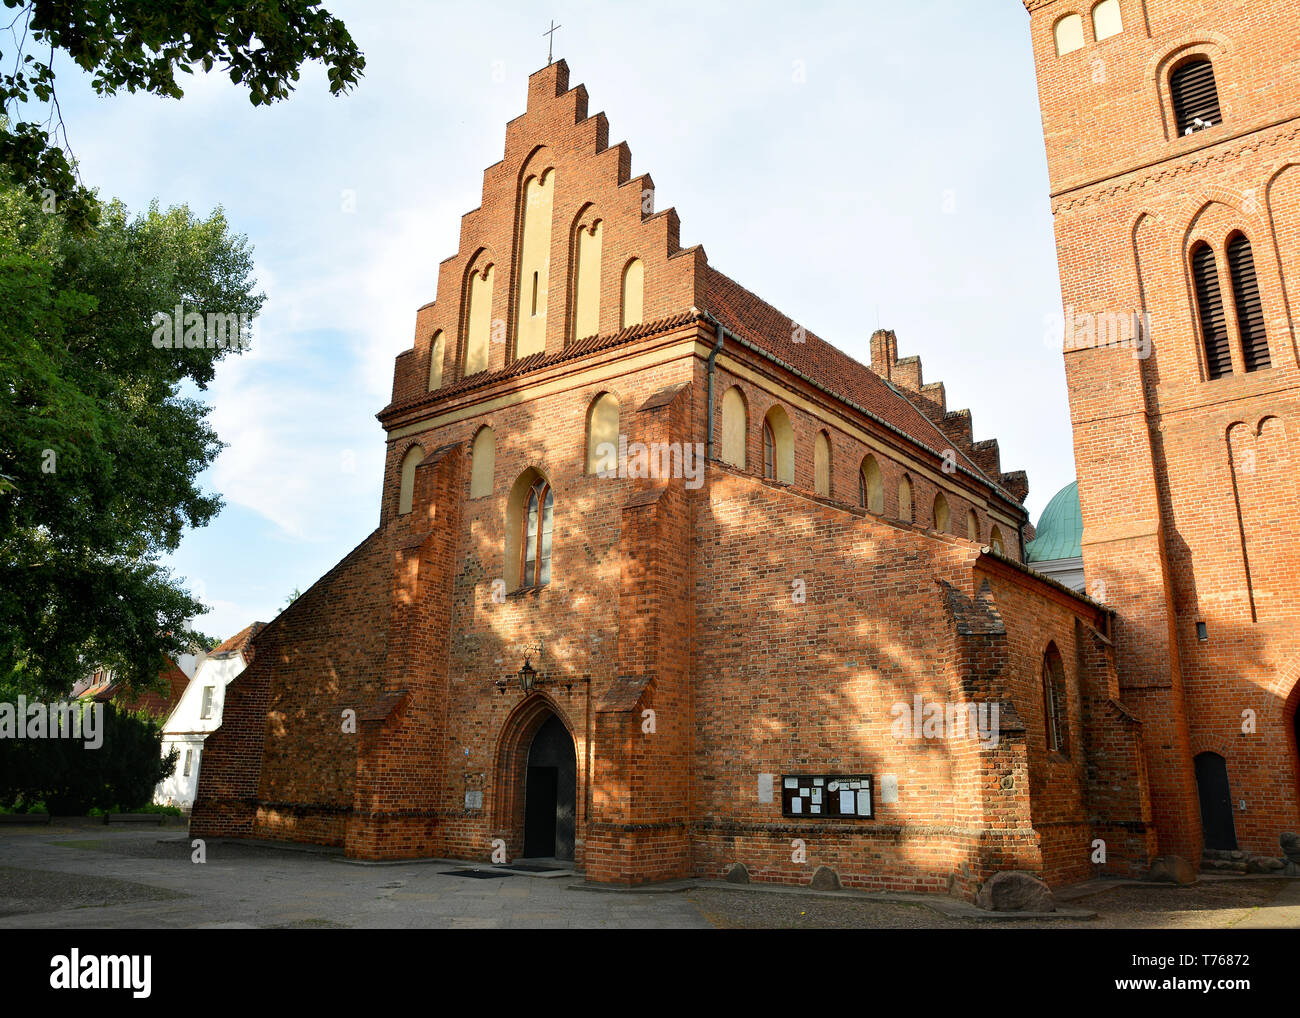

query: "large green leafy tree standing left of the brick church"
xmin=0 ymin=185 xmax=264 ymax=696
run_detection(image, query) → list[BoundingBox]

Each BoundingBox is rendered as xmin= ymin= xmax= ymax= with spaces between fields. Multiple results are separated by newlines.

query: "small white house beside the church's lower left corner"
xmin=153 ymin=623 xmax=267 ymax=810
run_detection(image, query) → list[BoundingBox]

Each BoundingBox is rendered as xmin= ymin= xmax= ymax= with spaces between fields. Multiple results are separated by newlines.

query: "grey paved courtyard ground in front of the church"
xmin=0 ymin=820 xmax=1300 ymax=930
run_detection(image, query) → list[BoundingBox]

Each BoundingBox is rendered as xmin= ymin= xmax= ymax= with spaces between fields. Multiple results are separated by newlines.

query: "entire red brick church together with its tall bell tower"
xmin=191 ymin=0 xmax=1300 ymax=897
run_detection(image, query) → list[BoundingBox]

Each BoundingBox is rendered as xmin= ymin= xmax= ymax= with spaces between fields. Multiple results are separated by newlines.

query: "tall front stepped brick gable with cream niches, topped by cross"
xmin=380 ymin=60 xmax=705 ymax=410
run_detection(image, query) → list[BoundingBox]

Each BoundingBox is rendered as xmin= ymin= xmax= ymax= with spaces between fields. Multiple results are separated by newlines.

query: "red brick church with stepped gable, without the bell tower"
xmin=191 ymin=3 xmax=1295 ymax=897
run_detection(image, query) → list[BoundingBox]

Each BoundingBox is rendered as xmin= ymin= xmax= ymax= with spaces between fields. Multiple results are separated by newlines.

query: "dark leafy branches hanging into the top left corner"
xmin=0 ymin=0 xmax=365 ymax=229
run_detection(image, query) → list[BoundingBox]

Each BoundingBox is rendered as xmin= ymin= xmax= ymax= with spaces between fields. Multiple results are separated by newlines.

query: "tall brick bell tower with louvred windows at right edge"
xmin=1024 ymin=0 xmax=1300 ymax=863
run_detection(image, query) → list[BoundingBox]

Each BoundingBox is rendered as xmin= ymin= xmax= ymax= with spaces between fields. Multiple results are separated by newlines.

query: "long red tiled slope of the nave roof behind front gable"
xmin=706 ymin=265 xmax=1001 ymax=490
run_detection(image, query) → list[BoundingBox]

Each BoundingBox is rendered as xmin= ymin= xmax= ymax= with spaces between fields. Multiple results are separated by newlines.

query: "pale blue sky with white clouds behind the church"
xmin=45 ymin=0 xmax=1074 ymax=637
